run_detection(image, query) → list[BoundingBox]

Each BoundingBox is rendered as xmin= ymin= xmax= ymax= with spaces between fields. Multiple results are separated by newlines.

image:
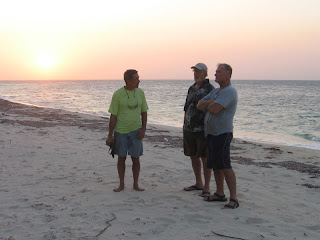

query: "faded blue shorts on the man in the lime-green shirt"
xmin=114 ymin=130 xmax=143 ymax=158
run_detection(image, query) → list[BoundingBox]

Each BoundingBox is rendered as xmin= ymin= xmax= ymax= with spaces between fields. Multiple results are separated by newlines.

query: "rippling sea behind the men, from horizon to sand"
xmin=0 ymin=80 xmax=320 ymax=150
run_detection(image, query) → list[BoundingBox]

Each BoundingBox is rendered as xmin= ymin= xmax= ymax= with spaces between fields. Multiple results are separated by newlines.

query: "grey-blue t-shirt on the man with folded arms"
xmin=203 ymin=84 xmax=238 ymax=136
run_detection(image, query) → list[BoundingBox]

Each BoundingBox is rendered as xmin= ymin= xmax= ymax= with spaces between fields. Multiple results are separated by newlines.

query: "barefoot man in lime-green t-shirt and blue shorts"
xmin=106 ymin=69 xmax=148 ymax=192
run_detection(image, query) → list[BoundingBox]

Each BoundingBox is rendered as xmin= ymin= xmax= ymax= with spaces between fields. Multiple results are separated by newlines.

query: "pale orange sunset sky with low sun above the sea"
xmin=0 ymin=0 xmax=320 ymax=80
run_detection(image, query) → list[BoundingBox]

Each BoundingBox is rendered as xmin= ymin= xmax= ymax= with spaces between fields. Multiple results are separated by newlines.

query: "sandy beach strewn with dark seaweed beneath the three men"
xmin=0 ymin=99 xmax=320 ymax=240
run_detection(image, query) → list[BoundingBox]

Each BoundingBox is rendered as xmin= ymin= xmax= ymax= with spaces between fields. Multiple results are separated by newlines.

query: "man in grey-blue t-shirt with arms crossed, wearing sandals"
xmin=197 ymin=64 xmax=239 ymax=209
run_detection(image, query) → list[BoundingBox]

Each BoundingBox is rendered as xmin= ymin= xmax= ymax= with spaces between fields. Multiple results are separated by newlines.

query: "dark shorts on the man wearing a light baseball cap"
xmin=183 ymin=130 xmax=207 ymax=158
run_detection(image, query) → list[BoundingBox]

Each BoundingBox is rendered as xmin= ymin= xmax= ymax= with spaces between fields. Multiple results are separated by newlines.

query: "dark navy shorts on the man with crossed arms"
xmin=207 ymin=132 xmax=233 ymax=170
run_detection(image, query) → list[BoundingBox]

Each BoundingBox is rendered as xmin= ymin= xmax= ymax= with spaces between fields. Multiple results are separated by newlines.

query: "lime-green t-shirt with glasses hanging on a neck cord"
xmin=109 ymin=87 xmax=149 ymax=134
